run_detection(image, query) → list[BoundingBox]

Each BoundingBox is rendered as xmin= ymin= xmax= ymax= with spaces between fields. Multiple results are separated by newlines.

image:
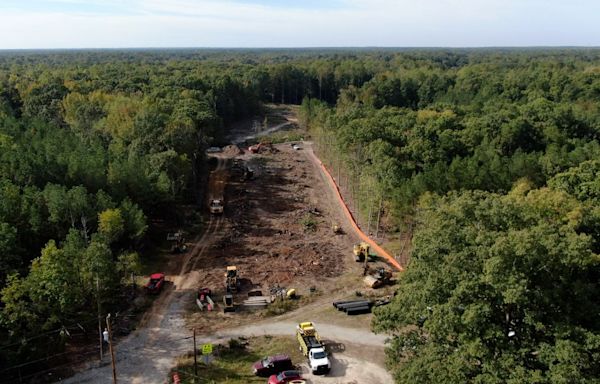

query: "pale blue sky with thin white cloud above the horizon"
xmin=0 ymin=0 xmax=600 ymax=49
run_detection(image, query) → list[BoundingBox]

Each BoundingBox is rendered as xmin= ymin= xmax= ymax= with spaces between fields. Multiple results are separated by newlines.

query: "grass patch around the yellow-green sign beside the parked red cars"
xmin=174 ymin=329 xmax=304 ymax=384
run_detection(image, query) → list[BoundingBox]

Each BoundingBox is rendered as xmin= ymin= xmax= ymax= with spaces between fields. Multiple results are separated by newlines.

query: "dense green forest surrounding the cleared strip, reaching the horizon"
xmin=0 ymin=49 xmax=600 ymax=383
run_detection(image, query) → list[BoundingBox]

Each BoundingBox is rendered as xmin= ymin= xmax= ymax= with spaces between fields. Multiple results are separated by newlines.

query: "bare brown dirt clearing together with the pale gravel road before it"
xmin=64 ymin=108 xmax=392 ymax=384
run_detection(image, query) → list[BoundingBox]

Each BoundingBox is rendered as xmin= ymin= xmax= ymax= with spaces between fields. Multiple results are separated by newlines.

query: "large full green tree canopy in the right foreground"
xmin=373 ymin=182 xmax=600 ymax=384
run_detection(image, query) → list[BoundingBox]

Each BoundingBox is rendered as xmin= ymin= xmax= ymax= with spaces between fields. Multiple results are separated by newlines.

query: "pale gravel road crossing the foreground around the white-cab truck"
xmin=62 ymin=316 xmax=392 ymax=384
